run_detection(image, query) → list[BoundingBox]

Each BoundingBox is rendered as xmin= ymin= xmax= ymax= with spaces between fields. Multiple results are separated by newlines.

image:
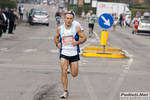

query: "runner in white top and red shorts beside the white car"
xmin=132 ymin=15 xmax=141 ymax=36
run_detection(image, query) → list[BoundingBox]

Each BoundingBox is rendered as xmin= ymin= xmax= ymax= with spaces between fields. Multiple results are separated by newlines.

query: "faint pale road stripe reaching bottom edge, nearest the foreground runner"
xmin=82 ymin=75 xmax=98 ymax=100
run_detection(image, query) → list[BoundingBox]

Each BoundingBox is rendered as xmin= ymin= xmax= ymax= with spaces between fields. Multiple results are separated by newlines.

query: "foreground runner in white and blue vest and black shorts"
xmin=54 ymin=11 xmax=86 ymax=98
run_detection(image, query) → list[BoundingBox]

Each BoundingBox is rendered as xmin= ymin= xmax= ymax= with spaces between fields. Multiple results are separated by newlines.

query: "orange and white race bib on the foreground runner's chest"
xmin=62 ymin=33 xmax=74 ymax=45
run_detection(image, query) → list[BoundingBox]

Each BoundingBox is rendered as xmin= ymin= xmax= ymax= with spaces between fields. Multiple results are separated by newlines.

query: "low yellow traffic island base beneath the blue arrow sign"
xmin=82 ymin=46 xmax=125 ymax=58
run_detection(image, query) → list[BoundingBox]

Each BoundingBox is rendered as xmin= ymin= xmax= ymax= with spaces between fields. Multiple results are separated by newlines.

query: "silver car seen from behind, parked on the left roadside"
xmin=29 ymin=9 xmax=50 ymax=26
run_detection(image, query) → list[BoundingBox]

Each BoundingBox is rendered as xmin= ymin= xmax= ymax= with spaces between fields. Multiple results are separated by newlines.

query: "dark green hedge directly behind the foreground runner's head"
xmin=68 ymin=5 xmax=96 ymax=15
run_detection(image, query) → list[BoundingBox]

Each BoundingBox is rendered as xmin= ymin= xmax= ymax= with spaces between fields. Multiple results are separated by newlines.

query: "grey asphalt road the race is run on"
xmin=0 ymin=4 xmax=150 ymax=100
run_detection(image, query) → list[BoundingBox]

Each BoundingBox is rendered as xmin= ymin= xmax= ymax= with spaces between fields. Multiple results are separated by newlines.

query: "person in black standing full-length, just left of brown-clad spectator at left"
xmin=8 ymin=8 xmax=16 ymax=34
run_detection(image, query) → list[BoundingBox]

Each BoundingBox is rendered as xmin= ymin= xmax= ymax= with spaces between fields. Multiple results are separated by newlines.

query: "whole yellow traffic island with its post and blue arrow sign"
xmin=82 ymin=13 xmax=125 ymax=58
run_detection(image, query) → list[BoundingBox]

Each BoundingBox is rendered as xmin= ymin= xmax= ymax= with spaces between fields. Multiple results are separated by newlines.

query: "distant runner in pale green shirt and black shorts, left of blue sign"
xmin=87 ymin=10 xmax=96 ymax=37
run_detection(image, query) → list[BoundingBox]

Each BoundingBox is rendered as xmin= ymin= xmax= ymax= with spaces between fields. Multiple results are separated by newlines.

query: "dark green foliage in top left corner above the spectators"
xmin=0 ymin=1 xmax=17 ymax=9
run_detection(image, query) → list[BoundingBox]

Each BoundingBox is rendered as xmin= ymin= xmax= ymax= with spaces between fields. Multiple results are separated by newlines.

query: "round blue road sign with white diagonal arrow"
xmin=98 ymin=13 xmax=114 ymax=29
